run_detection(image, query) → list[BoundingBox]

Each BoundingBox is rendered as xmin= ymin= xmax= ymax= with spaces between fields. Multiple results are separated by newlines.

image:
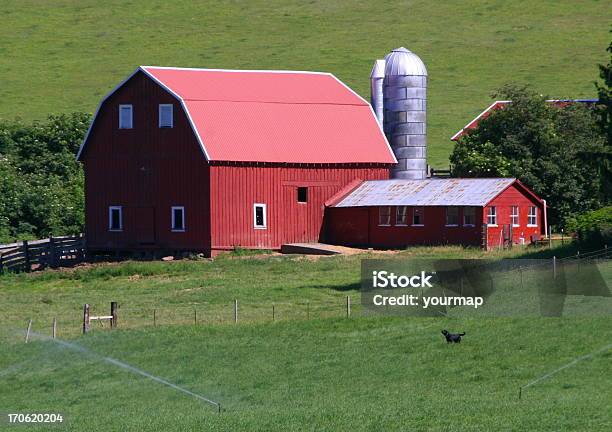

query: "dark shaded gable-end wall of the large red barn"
xmin=81 ymin=72 xmax=210 ymax=250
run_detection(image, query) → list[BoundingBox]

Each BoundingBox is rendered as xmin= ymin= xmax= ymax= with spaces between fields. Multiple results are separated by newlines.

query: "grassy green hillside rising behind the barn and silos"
xmin=0 ymin=0 xmax=612 ymax=168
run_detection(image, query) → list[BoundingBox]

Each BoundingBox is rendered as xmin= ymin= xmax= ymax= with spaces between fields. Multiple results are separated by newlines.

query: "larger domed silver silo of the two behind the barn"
xmin=383 ymin=47 xmax=427 ymax=180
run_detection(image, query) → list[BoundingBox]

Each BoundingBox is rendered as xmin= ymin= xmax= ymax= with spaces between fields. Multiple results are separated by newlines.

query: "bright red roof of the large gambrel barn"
xmin=140 ymin=66 xmax=396 ymax=164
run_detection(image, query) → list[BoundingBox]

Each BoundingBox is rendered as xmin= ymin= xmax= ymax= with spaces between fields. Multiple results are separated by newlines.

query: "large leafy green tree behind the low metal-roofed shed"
xmin=450 ymin=85 xmax=609 ymax=225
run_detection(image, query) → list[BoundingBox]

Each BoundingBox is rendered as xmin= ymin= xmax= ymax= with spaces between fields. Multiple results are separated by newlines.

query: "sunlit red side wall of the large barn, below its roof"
xmin=210 ymin=165 xmax=389 ymax=250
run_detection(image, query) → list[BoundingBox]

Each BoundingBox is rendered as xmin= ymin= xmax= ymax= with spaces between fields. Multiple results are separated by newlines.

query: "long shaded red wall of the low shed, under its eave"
xmin=328 ymin=207 xmax=482 ymax=248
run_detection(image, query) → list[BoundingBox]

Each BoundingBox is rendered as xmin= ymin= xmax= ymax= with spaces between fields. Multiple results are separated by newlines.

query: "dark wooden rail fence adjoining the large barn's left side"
xmin=0 ymin=234 xmax=86 ymax=274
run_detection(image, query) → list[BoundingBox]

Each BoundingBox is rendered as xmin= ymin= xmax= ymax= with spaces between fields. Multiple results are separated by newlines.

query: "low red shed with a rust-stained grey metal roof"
xmin=327 ymin=178 xmax=546 ymax=249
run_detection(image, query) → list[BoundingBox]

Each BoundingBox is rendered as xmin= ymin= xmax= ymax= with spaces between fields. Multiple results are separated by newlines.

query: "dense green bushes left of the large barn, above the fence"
xmin=0 ymin=113 xmax=91 ymax=243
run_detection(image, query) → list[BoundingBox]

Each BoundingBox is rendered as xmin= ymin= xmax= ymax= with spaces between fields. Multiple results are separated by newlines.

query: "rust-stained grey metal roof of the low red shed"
xmin=333 ymin=178 xmax=516 ymax=207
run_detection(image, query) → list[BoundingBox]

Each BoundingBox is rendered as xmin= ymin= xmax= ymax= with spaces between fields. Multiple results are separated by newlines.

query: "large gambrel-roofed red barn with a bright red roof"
xmin=77 ymin=67 xmax=396 ymax=255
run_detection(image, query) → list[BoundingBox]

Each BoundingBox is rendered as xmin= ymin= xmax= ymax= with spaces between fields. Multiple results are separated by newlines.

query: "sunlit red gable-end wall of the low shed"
xmin=482 ymin=184 xmax=544 ymax=248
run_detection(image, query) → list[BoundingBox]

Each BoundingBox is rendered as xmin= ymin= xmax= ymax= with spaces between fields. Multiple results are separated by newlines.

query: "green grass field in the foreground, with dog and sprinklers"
xmin=0 ymin=247 xmax=612 ymax=431
